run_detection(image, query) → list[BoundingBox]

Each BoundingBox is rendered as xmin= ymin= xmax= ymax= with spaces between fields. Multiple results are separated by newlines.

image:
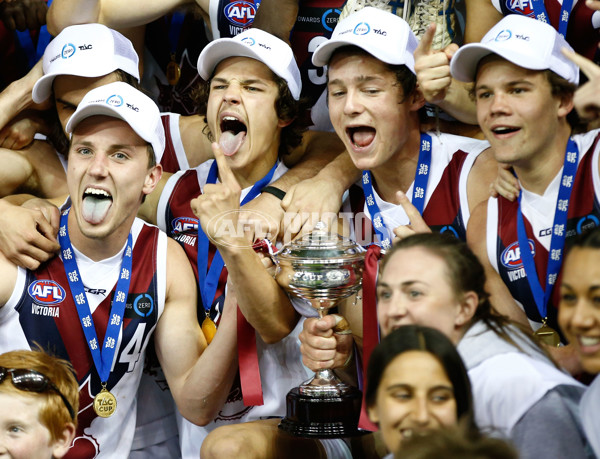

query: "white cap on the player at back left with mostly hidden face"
xmin=32 ymin=24 xmax=140 ymax=103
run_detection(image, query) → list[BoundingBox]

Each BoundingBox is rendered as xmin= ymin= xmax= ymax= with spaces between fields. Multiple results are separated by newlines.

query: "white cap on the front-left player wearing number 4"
xmin=66 ymin=81 xmax=165 ymax=157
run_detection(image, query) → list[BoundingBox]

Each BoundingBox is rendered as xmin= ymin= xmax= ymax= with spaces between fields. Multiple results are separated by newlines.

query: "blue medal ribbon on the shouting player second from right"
xmin=362 ymin=133 xmax=431 ymax=249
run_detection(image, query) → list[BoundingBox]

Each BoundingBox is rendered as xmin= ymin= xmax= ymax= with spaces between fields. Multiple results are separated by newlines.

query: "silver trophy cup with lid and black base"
xmin=276 ymin=222 xmax=365 ymax=438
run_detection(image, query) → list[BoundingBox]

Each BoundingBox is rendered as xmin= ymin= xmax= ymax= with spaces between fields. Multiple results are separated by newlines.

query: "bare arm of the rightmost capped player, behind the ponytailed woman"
xmin=467 ymin=201 xmax=531 ymax=328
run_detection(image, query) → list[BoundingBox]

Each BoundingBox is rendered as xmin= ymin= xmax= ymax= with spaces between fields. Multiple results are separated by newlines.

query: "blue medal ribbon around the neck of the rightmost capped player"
xmin=517 ymin=138 xmax=579 ymax=319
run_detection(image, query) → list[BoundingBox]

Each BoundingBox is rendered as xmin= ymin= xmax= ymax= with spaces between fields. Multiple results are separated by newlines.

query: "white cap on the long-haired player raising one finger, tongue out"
xmin=198 ymin=28 xmax=302 ymax=100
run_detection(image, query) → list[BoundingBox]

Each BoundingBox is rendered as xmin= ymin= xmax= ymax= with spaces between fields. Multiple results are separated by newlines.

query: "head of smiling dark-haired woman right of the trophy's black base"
xmin=366 ymin=325 xmax=476 ymax=458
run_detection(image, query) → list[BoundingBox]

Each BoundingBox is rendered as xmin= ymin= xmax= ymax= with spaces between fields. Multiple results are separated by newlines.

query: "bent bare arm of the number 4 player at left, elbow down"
xmin=154 ymin=239 xmax=237 ymax=425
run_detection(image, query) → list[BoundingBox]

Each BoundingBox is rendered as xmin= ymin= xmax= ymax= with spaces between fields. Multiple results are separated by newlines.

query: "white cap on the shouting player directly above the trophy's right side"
xmin=312 ymin=6 xmax=419 ymax=73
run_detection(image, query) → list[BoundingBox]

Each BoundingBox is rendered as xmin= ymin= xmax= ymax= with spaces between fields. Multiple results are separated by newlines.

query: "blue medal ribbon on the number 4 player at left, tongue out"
xmin=58 ymin=208 xmax=133 ymax=383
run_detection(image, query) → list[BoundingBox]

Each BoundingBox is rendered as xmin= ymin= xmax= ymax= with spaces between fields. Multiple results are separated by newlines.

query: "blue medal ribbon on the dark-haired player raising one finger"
xmin=196 ymin=161 xmax=279 ymax=313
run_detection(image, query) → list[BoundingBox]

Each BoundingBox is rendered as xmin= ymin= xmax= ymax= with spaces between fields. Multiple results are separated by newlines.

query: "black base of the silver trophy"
xmin=279 ymin=387 xmax=362 ymax=438
